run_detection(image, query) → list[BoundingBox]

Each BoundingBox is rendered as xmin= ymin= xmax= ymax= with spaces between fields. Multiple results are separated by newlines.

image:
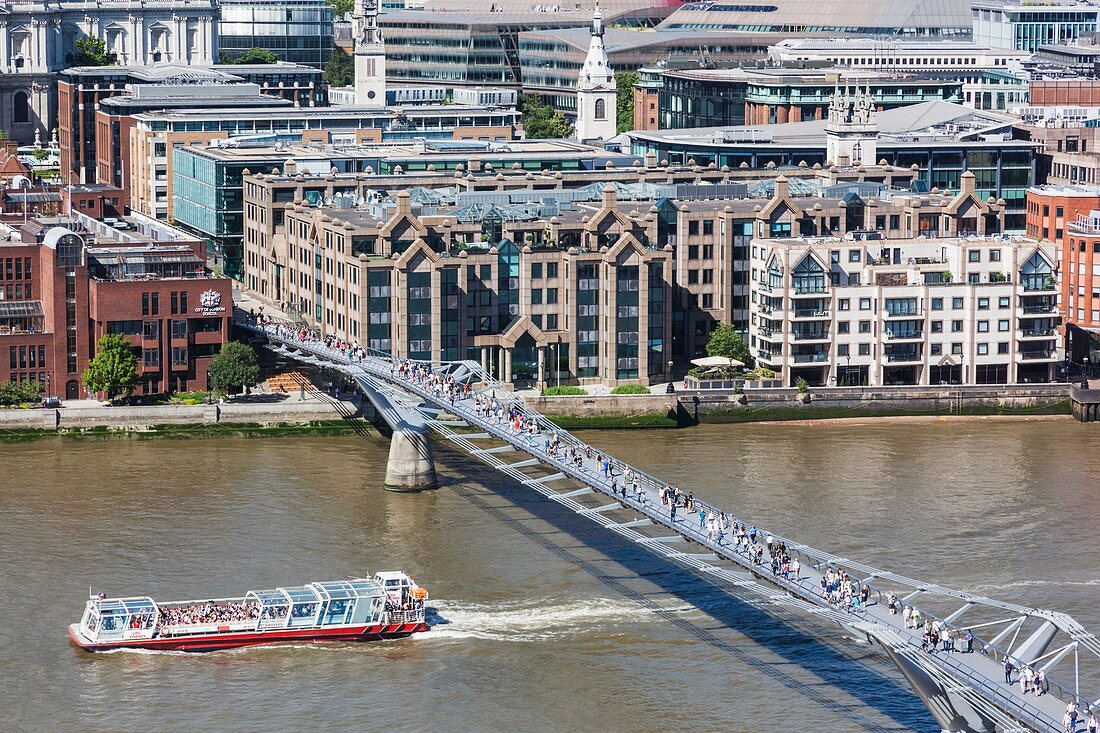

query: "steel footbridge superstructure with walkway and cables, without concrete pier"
xmin=244 ymin=322 xmax=1100 ymax=732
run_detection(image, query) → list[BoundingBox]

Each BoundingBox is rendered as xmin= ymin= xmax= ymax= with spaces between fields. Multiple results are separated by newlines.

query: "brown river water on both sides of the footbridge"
xmin=0 ymin=419 xmax=1100 ymax=733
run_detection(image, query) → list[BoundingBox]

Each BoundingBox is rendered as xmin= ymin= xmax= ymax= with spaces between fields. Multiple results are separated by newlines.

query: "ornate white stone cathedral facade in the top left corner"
xmin=0 ymin=0 xmax=218 ymax=142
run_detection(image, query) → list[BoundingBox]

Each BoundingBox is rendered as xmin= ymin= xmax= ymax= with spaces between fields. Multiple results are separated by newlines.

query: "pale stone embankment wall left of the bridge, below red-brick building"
xmin=0 ymin=401 xmax=358 ymax=433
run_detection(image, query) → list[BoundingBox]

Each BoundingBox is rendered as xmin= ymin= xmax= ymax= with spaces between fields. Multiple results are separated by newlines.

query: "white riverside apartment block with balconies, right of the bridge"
xmin=749 ymin=236 xmax=1062 ymax=386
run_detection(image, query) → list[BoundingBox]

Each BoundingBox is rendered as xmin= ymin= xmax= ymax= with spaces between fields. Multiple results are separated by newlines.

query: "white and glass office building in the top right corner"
xmin=971 ymin=0 xmax=1100 ymax=53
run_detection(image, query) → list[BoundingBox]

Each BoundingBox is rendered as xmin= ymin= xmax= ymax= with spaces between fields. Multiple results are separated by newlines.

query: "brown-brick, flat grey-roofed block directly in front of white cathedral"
xmin=57 ymin=63 xmax=328 ymax=186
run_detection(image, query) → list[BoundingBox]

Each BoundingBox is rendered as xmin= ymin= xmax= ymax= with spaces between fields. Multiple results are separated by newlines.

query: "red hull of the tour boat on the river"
xmin=68 ymin=622 xmax=428 ymax=652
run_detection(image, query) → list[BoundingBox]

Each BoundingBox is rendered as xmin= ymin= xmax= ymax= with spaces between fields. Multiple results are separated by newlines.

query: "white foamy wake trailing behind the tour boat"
xmin=418 ymin=598 xmax=696 ymax=642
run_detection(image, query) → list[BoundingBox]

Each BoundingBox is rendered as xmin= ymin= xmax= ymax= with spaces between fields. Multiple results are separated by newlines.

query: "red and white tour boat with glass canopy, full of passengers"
xmin=68 ymin=571 xmax=428 ymax=652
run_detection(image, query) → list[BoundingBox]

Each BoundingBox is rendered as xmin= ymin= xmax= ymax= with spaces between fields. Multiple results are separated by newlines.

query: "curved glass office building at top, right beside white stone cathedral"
xmin=218 ymin=0 xmax=336 ymax=68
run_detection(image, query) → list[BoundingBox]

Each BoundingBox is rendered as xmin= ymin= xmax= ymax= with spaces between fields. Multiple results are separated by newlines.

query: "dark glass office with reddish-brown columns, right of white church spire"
xmin=659 ymin=68 xmax=963 ymax=130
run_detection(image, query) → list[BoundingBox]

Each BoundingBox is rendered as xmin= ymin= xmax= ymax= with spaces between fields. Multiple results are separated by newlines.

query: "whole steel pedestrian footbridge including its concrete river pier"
xmin=235 ymin=317 xmax=1100 ymax=733
